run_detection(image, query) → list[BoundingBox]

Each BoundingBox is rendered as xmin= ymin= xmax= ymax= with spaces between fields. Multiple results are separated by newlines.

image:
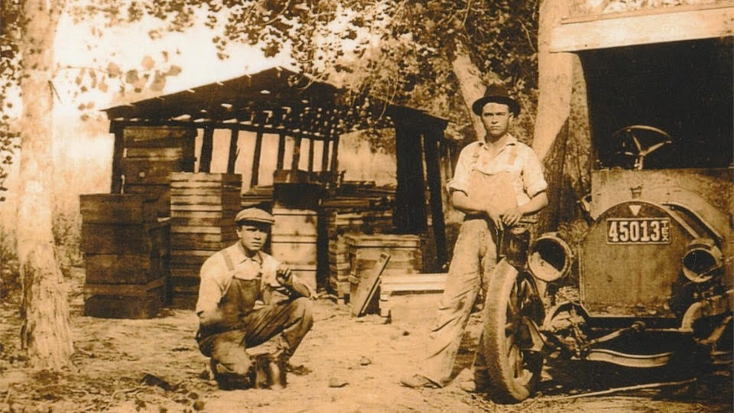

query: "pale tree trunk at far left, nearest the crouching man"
xmin=16 ymin=0 xmax=74 ymax=370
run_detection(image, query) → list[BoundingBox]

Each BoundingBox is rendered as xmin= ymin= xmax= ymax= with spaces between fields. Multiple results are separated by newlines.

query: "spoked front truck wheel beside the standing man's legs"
xmin=481 ymin=262 xmax=543 ymax=403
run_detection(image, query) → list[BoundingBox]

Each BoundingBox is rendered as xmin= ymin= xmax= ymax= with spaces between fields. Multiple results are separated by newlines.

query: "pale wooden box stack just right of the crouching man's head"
xmin=271 ymin=207 xmax=319 ymax=289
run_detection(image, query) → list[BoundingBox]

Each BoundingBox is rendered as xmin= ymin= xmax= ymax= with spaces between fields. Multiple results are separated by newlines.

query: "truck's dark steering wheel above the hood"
xmin=611 ymin=125 xmax=674 ymax=170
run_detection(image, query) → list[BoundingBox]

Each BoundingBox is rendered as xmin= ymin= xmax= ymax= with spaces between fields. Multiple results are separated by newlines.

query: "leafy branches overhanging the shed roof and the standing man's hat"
xmin=192 ymin=0 xmax=538 ymax=126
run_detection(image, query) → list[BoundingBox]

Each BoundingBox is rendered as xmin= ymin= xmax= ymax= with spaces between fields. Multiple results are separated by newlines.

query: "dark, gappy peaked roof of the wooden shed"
xmin=104 ymin=67 xmax=445 ymax=138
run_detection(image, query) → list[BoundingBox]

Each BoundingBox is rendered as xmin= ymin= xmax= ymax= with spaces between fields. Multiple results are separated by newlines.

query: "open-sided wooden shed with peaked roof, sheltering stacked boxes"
xmin=87 ymin=67 xmax=448 ymax=306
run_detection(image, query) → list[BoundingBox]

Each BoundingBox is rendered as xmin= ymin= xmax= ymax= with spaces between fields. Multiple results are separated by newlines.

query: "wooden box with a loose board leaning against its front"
xmin=346 ymin=234 xmax=423 ymax=312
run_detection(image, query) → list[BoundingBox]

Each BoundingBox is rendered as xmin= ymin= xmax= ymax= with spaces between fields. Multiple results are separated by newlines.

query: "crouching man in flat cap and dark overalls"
xmin=196 ymin=208 xmax=313 ymax=389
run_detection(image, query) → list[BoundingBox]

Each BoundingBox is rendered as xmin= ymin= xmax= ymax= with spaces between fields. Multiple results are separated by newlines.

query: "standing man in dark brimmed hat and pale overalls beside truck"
xmin=401 ymin=85 xmax=548 ymax=391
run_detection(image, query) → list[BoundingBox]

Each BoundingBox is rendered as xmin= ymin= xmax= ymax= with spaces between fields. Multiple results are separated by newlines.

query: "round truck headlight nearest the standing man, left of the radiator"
xmin=528 ymin=232 xmax=573 ymax=282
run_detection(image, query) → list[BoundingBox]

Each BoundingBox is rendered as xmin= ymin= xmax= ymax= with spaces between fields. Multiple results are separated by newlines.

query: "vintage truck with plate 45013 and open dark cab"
xmin=486 ymin=3 xmax=734 ymax=403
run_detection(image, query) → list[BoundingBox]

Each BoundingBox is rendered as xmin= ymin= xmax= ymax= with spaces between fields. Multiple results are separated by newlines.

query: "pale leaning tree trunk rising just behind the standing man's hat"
xmin=451 ymin=36 xmax=499 ymax=138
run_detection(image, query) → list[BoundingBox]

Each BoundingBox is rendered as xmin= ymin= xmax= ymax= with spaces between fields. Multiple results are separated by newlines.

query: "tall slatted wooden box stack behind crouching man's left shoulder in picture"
xmin=171 ymin=172 xmax=242 ymax=309
